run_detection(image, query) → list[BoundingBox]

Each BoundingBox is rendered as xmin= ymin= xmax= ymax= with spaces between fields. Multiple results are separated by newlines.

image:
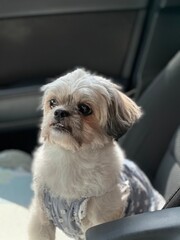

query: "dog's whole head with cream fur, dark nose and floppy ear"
xmin=41 ymin=69 xmax=141 ymax=151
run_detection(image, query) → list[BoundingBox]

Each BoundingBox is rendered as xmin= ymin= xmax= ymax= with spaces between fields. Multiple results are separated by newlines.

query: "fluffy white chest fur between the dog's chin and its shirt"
xmin=34 ymin=142 xmax=123 ymax=199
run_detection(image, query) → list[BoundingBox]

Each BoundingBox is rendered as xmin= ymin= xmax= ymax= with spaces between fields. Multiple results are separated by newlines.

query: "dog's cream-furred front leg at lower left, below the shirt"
xmin=28 ymin=199 xmax=55 ymax=240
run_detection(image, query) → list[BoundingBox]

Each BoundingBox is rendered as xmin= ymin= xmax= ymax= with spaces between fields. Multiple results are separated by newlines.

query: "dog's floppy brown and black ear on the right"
xmin=106 ymin=88 xmax=142 ymax=140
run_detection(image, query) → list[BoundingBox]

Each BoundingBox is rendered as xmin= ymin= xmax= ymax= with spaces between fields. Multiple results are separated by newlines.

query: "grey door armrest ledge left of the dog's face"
xmin=0 ymin=86 xmax=41 ymax=128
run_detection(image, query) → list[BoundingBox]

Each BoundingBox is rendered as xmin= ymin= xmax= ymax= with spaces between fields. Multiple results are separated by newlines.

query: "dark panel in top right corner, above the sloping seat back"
xmin=133 ymin=0 xmax=180 ymax=97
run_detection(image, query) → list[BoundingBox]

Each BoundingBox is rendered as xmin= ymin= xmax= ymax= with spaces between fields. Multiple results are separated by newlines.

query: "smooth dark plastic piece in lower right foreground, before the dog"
xmin=86 ymin=207 xmax=180 ymax=240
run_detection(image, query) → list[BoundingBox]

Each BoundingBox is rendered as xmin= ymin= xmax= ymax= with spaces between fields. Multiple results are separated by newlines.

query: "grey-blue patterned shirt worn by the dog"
xmin=44 ymin=160 xmax=164 ymax=239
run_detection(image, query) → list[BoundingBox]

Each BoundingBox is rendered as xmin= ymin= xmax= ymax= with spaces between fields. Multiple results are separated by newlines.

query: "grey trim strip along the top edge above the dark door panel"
xmin=0 ymin=0 xmax=148 ymax=18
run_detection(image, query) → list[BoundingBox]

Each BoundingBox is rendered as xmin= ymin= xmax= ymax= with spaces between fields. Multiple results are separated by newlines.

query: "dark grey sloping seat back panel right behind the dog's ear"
xmin=120 ymin=52 xmax=180 ymax=181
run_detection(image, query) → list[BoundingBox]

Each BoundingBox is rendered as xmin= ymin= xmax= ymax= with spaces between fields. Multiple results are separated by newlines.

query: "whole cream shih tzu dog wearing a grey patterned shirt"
xmin=29 ymin=69 xmax=164 ymax=240
